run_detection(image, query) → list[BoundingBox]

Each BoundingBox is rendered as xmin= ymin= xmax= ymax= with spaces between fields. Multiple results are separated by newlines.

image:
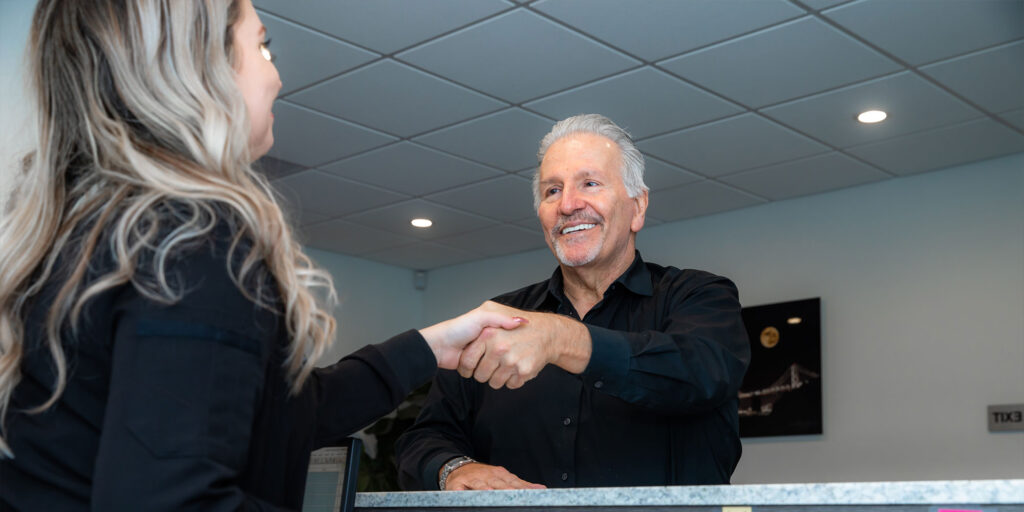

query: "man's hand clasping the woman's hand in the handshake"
xmin=458 ymin=301 xmax=592 ymax=389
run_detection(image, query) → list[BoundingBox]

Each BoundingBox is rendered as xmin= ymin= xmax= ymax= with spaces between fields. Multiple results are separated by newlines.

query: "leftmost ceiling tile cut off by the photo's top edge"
xmin=253 ymin=0 xmax=512 ymax=53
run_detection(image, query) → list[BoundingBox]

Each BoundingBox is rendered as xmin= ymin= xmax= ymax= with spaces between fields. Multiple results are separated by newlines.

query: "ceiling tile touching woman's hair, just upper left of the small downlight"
xmin=273 ymin=169 xmax=406 ymax=217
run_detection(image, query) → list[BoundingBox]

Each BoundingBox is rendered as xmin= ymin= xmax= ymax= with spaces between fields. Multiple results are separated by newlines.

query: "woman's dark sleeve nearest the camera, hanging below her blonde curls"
xmin=92 ymin=237 xmax=280 ymax=511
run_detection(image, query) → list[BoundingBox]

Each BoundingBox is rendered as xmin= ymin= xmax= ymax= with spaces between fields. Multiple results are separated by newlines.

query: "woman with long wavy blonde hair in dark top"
xmin=0 ymin=0 xmax=521 ymax=511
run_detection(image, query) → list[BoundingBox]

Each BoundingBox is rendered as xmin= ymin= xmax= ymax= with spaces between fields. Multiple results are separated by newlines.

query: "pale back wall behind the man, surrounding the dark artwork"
xmin=424 ymin=154 xmax=1024 ymax=483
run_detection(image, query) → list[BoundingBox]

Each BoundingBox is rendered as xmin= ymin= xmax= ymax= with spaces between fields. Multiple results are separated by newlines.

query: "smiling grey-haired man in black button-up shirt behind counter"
xmin=397 ymin=115 xmax=750 ymax=489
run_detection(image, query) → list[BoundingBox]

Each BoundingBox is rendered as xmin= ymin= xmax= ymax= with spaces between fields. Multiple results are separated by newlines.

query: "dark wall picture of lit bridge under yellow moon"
xmin=739 ymin=298 xmax=822 ymax=437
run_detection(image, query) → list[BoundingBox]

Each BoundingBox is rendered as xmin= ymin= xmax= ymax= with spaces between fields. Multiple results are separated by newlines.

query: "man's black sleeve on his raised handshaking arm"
xmin=583 ymin=272 xmax=751 ymax=415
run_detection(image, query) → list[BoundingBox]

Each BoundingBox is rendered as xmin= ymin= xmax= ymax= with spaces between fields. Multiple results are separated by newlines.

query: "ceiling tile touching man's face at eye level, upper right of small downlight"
xmin=426 ymin=175 xmax=537 ymax=221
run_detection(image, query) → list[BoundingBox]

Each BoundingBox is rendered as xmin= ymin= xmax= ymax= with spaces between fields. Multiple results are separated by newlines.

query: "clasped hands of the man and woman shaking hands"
xmin=420 ymin=301 xmax=591 ymax=389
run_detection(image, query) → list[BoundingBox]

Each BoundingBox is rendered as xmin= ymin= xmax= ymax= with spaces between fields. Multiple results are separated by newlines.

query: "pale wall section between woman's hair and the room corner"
xmin=306 ymin=249 xmax=424 ymax=365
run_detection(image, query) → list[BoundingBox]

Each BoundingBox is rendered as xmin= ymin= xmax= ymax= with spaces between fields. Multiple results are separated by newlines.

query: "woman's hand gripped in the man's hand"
xmin=420 ymin=302 xmax=527 ymax=370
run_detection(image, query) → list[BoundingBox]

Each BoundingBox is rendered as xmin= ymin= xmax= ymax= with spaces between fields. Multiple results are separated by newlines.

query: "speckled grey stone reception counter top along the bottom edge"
xmin=355 ymin=479 xmax=1024 ymax=512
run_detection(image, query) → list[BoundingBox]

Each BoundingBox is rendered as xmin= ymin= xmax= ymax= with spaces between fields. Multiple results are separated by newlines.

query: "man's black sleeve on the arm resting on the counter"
xmin=395 ymin=370 xmax=476 ymax=490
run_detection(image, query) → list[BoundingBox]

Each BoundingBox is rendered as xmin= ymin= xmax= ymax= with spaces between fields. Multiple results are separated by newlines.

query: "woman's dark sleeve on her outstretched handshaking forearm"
xmin=309 ymin=330 xmax=437 ymax=447
